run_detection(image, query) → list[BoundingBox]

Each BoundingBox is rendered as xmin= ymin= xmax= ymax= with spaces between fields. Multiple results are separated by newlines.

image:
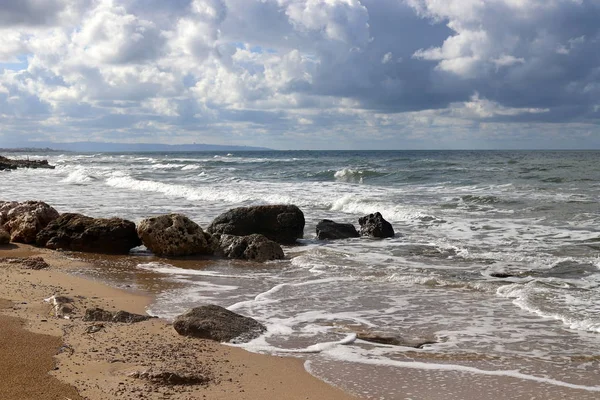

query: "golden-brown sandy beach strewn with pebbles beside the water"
xmin=0 ymin=244 xmax=355 ymax=400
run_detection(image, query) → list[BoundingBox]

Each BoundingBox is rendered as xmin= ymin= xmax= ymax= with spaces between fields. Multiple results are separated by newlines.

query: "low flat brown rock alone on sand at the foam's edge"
xmin=173 ymin=305 xmax=267 ymax=343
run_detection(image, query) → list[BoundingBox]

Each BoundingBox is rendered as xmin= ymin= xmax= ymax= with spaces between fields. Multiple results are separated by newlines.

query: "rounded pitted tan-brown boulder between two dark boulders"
xmin=137 ymin=214 xmax=218 ymax=256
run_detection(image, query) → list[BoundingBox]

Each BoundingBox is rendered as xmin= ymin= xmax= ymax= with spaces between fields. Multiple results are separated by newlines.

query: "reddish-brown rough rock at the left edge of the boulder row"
xmin=0 ymin=201 xmax=59 ymax=243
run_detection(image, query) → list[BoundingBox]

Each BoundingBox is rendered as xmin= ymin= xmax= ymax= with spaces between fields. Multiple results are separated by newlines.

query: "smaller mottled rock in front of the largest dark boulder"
xmin=215 ymin=234 xmax=284 ymax=262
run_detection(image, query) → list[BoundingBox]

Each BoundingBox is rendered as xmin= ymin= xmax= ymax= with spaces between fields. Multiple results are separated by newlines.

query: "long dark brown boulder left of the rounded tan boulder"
xmin=36 ymin=213 xmax=142 ymax=254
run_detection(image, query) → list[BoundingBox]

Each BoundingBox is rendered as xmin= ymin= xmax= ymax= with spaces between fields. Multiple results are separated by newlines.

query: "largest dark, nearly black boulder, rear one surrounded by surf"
xmin=206 ymin=205 xmax=304 ymax=244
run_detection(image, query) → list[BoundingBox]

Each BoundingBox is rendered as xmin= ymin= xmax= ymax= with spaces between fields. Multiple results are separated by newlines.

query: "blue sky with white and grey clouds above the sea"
xmin=0 ymin=0 xmax=600 ymax=149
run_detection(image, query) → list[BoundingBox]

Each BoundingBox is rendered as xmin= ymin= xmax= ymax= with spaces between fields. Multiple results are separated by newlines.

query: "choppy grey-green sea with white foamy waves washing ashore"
xmin=0 ymin=151 xmax=600 ymax=400
